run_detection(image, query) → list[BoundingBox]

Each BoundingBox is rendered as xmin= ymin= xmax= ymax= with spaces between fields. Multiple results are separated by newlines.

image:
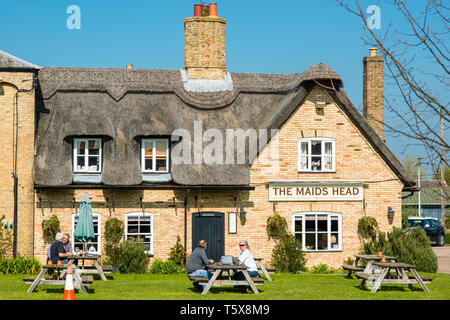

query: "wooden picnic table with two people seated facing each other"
xmin=190 ymin=263 xmax=265 ymax=294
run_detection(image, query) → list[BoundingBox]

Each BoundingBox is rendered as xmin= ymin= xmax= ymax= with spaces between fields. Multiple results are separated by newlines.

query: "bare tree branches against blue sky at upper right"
xmin=336 ymin=0 xmax=450 ymax=180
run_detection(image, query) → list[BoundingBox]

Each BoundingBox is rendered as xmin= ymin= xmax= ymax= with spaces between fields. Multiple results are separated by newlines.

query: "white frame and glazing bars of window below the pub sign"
xmin=292 ymin=211 xmax=342 ymax=252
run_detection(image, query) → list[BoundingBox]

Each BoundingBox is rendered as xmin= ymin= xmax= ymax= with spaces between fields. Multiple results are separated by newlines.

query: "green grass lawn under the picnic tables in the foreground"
xmin=0 ymin=273 xmax=450 ymax=301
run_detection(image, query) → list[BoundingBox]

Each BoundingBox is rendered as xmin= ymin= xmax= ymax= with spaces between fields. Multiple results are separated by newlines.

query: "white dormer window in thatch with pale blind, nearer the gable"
xmin=141 ymin=139 xmax=169 ymax=172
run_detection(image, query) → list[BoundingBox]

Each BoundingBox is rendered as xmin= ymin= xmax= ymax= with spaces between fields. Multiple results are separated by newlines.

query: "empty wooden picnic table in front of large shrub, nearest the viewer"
xmin=355 ymin=262 xmax=432 ymax=293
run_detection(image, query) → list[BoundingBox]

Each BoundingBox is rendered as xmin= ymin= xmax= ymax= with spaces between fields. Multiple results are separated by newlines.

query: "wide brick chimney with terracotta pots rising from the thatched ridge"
xmin=184 ymin=3 xmax=227 ymax=80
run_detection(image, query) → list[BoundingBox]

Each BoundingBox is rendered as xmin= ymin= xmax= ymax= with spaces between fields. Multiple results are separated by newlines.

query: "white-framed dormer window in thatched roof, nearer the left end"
xmin=73 ymin=138 xmax=102 ymax=173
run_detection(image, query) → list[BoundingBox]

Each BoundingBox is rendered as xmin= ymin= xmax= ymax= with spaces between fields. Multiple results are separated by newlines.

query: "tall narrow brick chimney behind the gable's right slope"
xmin=363 ymin=48 xmax=386 ymax=142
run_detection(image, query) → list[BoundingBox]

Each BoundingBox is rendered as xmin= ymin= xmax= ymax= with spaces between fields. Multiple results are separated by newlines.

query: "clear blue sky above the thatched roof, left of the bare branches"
xmin=0 ymin=0 xmax=442 ymax=176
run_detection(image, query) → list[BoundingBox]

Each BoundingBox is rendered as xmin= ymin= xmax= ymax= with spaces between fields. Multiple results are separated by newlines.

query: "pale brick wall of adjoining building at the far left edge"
xmin=0 ymin=71 xmax=35 ymax=256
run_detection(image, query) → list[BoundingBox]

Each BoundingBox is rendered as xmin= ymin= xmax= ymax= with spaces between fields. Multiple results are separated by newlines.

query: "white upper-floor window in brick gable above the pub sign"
xmin=298 ymin=138 xmax=336 ymax=172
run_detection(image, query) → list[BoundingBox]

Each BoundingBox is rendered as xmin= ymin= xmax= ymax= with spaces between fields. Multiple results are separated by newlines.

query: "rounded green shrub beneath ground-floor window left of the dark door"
xmin=113 ymin=240 xmax=148 ymax=273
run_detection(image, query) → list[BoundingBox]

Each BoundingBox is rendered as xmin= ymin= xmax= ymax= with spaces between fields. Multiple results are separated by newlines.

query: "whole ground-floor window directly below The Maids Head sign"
xmin=292 ymin=212 xmax=342 ymax=251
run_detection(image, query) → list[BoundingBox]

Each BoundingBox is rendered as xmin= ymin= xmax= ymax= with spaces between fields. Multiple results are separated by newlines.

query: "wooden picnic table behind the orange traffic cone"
xmin=23 ymin=265 xmax=93 ymax=294
